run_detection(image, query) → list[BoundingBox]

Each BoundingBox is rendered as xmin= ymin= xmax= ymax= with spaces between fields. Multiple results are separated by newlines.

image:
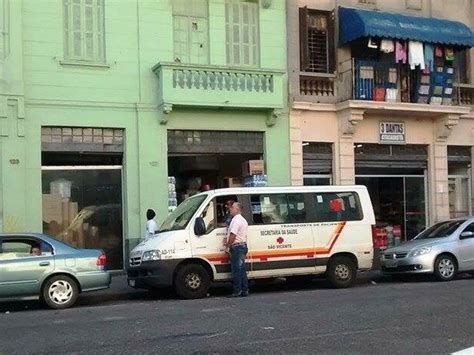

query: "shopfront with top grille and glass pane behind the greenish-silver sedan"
xmin=41 ymin=127 xmax=124 ymax=270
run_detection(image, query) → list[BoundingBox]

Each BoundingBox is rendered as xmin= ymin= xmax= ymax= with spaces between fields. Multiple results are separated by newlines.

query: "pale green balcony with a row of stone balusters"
xmin=153 ymin=63 xmax=285 ymax=113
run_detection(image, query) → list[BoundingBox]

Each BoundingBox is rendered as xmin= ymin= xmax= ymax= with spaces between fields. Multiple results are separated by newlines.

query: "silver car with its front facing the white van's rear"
xmin=381 ymin=217 xmax=474 ymax=281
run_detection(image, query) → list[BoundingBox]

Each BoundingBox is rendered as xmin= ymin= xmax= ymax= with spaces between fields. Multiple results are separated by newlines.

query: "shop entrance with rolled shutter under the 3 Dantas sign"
xmin=354 ymin=143 xmax=428 ymax=243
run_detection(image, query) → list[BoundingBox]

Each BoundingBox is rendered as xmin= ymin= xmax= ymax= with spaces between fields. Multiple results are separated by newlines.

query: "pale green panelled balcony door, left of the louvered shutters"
xmin=172 ymin=0 xmax=209 ymax=64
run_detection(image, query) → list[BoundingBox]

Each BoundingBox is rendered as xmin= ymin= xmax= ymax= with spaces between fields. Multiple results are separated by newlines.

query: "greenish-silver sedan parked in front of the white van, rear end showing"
xmin=0 ymin=234 xmax=111 ymax=309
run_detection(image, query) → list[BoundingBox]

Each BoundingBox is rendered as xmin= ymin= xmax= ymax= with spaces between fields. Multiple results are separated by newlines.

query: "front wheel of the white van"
xmin=174 ymin=264 xmax=211 ymax=300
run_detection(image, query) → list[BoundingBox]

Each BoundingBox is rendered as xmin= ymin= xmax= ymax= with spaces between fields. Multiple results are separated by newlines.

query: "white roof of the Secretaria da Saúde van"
xmin=195 ymin=185 xmax=367 ymax=196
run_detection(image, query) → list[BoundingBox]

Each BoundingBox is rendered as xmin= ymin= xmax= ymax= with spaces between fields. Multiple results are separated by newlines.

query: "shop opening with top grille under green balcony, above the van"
xmin=168 ymin=130 xmax=266 ymax=204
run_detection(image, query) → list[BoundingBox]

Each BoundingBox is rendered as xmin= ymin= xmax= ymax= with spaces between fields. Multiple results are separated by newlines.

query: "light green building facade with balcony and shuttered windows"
xmin=0 ymin=0 xmax=290 ymax=269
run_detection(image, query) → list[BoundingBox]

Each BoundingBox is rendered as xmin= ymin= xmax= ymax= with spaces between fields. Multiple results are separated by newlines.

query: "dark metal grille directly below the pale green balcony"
xmin=168 ymin=130 xmax=263 ymax=154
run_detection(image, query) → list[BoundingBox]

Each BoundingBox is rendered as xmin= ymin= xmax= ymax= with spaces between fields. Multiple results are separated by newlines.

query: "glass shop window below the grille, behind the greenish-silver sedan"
xmin=42 ymin=166 xmax=124 ymax=270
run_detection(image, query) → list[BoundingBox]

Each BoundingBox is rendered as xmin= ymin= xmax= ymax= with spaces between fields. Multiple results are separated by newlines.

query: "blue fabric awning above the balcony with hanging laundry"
xmin=339 ymin=7 xmax=474 ymax=47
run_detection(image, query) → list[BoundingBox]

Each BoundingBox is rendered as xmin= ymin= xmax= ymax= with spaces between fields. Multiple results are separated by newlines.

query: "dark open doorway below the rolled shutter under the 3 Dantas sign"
xmin=356 ymin=175 xmax=427 ymax=246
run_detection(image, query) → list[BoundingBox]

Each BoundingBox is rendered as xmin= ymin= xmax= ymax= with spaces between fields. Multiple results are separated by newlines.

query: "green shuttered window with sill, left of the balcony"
xmin=63 ymin=0 xmax=105 ymax=63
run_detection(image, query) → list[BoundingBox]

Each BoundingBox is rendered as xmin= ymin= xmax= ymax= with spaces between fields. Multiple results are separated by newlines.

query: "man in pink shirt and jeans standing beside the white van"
xmin=225 ymin=202 xmax=249 ymax=297
